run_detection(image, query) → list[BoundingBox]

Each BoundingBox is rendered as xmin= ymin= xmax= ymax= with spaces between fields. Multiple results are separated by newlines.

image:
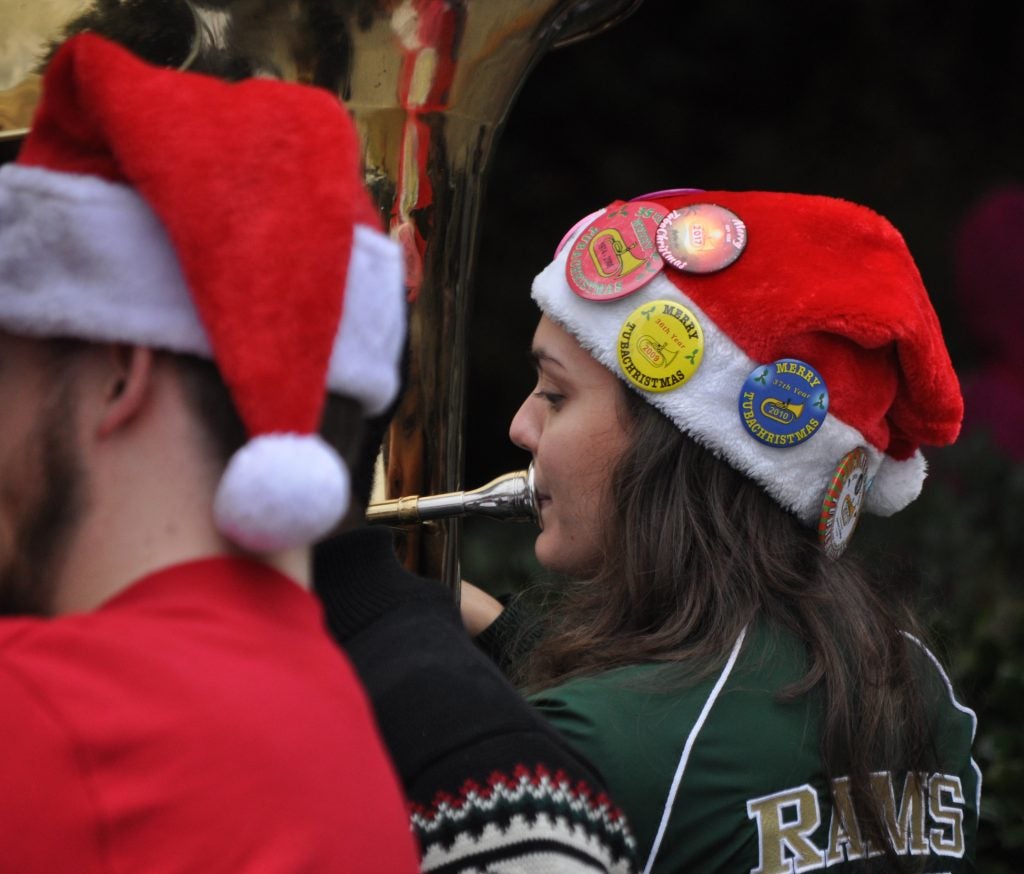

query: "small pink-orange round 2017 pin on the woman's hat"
xmin=654 ymin=204 xmax=746 ymax=273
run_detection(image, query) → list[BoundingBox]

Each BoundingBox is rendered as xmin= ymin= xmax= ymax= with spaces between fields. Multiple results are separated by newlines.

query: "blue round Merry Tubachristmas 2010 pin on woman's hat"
xmin=739 ymin=358 xmax=828 ymax=448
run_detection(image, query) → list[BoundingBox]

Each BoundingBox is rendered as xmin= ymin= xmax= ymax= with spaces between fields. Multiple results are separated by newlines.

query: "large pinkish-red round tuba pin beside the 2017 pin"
xmin=565 ymin=201 xmax=665 ymax=301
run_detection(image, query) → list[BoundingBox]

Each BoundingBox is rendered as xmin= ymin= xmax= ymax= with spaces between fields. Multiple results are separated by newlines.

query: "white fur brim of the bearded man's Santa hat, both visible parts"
xmin=0 ymin=164 xmax=406 ymax=414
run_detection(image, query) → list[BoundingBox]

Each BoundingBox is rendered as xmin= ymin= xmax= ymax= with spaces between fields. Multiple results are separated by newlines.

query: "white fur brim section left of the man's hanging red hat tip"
xmin=0 ymin=164 xmax=210 ymax=357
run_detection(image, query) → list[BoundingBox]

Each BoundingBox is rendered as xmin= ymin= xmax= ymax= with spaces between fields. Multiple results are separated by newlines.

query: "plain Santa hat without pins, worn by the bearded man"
xmin=0 ymin=34 xmax=406 ymax=553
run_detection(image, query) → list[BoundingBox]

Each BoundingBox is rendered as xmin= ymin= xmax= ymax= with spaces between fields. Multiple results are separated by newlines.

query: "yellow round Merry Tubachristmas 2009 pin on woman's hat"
xmin=618 ymin=300 xmax=703 ymax=392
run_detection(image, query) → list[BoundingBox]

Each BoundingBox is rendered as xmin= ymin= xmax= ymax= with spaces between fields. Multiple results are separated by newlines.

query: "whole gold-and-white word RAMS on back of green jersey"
xmin=746 ymin=771 xmax=965 ymax=874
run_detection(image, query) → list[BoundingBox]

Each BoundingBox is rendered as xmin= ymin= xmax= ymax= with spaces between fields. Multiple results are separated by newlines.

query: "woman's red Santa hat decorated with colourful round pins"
xmin=532 ymin=189 xmax=964 ymax=555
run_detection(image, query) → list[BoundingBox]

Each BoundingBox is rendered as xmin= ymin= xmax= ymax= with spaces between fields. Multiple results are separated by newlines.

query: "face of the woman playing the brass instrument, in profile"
xmin=509 ymin=316 xmax=628 ymax=577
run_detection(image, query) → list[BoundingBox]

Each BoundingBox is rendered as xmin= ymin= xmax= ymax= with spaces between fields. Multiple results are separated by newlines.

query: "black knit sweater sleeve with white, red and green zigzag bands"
xmin=314 ymin=529 xmax=637 ymax=874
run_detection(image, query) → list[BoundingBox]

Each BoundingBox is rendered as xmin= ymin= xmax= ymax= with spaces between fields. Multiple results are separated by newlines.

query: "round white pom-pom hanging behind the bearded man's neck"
xmin=213 ymin=434 xmax=349 ymax=554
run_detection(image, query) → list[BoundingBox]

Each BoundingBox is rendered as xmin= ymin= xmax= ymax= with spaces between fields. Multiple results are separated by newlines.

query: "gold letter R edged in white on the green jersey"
xmin=746 ymin=783 xmax=824 ymax=874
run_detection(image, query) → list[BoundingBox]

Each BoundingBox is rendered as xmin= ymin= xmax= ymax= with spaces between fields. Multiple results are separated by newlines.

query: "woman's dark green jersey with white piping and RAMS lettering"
xmin=532 ymin=627 xmax=981 ymax=874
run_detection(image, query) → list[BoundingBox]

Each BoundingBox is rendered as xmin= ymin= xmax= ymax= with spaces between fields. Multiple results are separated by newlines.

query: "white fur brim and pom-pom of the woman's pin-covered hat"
xmin=532 ymin=229 xmax=925 ymax=525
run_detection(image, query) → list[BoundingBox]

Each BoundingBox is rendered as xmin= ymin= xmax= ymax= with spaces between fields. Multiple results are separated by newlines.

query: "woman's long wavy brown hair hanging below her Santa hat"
xmin=521 ymin=388 xmax=934 ymax=862
